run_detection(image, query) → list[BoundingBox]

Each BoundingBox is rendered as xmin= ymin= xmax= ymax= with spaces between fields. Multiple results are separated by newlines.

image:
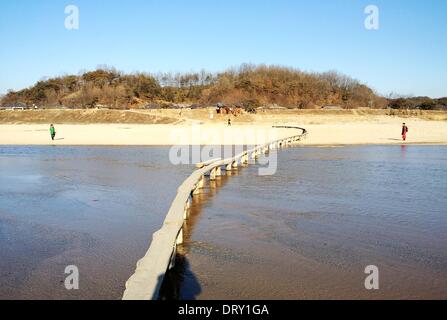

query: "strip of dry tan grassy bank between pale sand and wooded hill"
xmin=0 ymin=107 xmax=447 ymax=124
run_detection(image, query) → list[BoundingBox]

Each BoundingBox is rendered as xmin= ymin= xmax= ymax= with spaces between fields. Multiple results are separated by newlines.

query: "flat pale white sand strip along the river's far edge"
xmin=0 ymin=117 xmax=447 ymax=145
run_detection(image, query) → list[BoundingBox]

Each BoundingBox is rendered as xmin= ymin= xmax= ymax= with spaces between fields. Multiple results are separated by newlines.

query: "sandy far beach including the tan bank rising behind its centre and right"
xmin=0 ymin=110 xmax=447 ymax=145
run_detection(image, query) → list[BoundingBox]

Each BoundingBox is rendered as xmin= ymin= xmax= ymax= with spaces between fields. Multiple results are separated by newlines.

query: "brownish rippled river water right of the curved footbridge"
xmin=166 ymin=146 xmax=447 ymax=299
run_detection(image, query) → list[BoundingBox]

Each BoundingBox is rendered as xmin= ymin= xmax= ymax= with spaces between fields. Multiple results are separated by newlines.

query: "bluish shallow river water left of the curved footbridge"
xmin=0 ymin=147 xmax=192 ymax=299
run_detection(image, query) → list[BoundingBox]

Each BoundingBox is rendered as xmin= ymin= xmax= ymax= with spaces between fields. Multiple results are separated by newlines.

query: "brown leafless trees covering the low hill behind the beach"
xmin=1 ymin=64 xmax=447 ymax=109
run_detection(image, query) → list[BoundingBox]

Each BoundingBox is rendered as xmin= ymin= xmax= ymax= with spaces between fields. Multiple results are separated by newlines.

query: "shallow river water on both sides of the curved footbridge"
xmin=0 ymin=145 xmax=447 ymax=299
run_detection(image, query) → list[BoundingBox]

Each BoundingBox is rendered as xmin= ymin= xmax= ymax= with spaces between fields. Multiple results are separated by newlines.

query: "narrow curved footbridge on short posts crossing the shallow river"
xmin=123 ymin=126 xmax=307 ymax=300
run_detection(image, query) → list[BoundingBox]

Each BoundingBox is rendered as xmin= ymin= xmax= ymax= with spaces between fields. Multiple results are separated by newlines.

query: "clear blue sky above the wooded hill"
xmin=0 ymin=0 xmax=447 ymax=97
